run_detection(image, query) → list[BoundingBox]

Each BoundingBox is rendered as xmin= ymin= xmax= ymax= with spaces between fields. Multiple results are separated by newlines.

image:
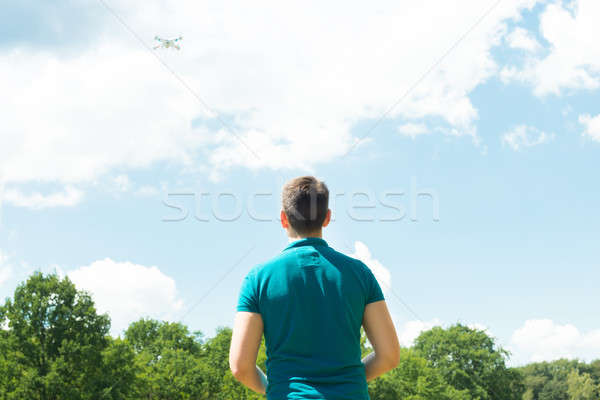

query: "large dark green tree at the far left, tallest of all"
xmin=0 ymin=272 xmax=135 ymax=400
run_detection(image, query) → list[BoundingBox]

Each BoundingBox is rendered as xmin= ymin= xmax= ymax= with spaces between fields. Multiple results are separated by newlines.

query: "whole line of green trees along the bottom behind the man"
xmin=0 ymin=273 xmax=600 ymax=400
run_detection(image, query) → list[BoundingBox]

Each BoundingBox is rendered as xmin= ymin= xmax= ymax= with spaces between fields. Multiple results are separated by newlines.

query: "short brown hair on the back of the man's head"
xmin=281 ymin=176 xmax=329 ymax=235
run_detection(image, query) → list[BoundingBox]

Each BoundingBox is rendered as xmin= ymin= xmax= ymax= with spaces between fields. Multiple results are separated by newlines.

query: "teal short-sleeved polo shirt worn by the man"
xmin=237 ymin=238 xmax=384 ymax=400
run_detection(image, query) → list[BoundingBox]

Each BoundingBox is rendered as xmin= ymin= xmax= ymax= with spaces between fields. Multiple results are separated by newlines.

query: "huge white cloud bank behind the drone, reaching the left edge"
xmin=0 ymin=0 xmax=536 ymax=184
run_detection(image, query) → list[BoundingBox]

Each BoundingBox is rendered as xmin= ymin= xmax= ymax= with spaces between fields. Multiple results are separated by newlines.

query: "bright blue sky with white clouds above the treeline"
xmin=0 ymin=0 xmax=600 ymax=365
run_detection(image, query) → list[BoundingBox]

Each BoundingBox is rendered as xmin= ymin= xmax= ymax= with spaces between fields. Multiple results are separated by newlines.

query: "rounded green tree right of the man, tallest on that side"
xmin=414 ymin=324 xmax=524 ymax=400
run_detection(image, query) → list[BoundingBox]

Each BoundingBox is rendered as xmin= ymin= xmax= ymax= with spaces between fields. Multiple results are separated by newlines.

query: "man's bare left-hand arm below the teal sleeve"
xmin=229 ymin=312 xmax=267 ymax=394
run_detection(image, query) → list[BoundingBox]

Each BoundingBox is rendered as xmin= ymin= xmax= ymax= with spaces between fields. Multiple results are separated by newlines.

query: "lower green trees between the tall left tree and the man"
xmin=120 ymin=319 xmax=266 ymax=400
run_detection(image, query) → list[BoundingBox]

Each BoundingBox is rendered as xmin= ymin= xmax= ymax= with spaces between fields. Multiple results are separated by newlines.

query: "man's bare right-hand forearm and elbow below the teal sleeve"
xmin=362 ymin=300 xmax=400 ymax=381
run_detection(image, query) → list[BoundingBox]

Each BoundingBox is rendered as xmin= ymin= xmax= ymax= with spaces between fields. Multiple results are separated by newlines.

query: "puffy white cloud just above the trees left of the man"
xmin=67 ymin=258 xmax=183 ymax=334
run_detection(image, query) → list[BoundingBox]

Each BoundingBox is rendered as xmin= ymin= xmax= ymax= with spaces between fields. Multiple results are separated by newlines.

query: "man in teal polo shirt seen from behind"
xmin=229 ymin=176 xmax=400 ymax=400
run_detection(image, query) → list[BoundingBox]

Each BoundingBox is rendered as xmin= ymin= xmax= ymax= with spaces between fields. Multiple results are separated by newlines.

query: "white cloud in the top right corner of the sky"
xmin=501 ymin=0 xmax=600 ymax=95
